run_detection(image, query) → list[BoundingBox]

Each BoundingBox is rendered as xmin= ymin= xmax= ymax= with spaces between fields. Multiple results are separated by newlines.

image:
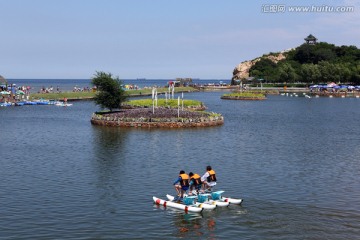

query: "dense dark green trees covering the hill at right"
xmin=249 ymin=42 xmax=360 ymax=85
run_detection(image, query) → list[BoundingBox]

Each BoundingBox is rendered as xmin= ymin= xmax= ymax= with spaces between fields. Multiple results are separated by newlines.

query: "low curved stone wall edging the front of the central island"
xmin=91 ymin=113 xmax=224 ymax=128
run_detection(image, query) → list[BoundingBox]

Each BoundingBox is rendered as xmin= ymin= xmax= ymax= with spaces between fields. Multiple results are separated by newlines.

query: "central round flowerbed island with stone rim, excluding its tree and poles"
xmin=91 ymin=99 xmax=224 ymax=128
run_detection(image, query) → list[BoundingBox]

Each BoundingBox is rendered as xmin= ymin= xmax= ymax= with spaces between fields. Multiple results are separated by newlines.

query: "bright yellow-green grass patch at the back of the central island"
xmin=123 ymin=98 xmax=203 ymax=108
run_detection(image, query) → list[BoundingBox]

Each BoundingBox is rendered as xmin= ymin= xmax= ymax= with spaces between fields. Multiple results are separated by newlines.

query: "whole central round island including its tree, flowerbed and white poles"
xmin=90 ymin=72 xmax=224 ymax=128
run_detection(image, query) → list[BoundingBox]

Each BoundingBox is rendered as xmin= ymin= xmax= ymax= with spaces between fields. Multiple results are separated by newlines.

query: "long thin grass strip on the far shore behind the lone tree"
xmin=30 ymin=87 xmax=197 ymax=100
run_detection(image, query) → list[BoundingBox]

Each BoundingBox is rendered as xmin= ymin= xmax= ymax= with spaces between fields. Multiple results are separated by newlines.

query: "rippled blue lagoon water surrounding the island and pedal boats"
xmin=0 ymin=92 xmax=360 ymax=239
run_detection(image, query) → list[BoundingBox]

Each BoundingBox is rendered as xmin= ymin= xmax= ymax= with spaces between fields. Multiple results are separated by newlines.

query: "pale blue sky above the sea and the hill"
xmin=0 ymin=0 xmax=360 ymax=79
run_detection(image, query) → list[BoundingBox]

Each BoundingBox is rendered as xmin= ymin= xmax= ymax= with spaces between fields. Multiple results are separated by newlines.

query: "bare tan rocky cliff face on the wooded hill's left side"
xmin=232 ymin=49 xmax=292 ymax=80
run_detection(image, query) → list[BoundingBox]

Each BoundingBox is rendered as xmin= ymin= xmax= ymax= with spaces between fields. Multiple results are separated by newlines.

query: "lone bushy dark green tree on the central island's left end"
xmin=91 ymin=72 xmax=127 ymax=111
